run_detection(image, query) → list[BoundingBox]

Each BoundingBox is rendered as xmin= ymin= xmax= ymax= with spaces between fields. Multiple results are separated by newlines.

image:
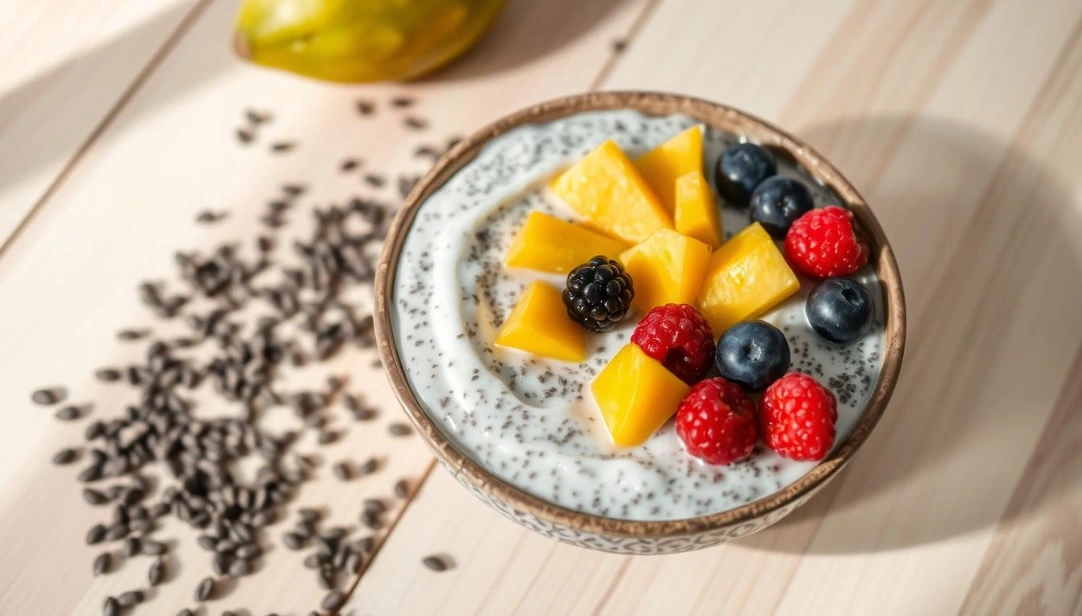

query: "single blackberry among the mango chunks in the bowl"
xmin=564 ymin=255 xmax=635 ymax=331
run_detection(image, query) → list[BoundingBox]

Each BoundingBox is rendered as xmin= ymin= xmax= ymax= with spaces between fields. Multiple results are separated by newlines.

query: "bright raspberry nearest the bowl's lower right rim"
xmin=758 ymin=372 xmax=837 ymax=460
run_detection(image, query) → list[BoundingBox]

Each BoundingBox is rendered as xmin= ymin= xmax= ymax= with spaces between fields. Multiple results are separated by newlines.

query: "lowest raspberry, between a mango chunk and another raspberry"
xmin=676 ymin=377 xmax=758 ymax=464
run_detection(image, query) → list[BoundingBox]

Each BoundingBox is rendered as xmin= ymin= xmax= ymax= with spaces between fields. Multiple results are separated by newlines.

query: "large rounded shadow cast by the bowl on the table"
xmin=739 ymin=116 xmax=1082 ymax=553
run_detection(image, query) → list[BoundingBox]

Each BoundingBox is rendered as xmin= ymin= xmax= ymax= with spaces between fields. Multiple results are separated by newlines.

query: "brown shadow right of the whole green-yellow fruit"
xmin=422 ymin=0 xmax=631 ymax=82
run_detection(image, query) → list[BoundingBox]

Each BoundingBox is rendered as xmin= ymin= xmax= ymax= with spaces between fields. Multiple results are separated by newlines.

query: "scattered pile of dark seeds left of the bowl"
xmin=30 ymin=96 xmax=457 ymax=616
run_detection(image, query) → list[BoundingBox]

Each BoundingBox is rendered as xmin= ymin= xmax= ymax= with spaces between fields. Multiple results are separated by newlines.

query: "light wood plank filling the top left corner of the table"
xmin=0 ymin=0 xmax=205 ymax=247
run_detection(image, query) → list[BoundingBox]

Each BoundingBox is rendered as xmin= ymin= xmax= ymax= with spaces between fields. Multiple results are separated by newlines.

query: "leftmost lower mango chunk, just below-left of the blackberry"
xmin=496 ymin=280 xmax=586 ymax=362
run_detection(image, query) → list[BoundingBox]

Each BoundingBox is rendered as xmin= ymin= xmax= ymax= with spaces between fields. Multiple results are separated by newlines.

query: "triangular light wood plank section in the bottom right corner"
xmin=961 ymin=346 xmax=1082 ymax=615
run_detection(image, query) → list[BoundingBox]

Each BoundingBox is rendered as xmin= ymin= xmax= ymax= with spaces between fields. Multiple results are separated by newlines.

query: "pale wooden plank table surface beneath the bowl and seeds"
xmin=0 ymin=0 xmax=1082 ymax=615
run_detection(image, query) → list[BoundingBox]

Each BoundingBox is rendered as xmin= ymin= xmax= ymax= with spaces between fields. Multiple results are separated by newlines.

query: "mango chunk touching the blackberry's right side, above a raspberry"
xmin=620 ymin=228 xmax=710 ymax=312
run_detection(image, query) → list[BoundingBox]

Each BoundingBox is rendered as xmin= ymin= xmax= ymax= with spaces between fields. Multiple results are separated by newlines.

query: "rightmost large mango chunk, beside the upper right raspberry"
xmin=698 ymin=223 xmax=801 ymax=336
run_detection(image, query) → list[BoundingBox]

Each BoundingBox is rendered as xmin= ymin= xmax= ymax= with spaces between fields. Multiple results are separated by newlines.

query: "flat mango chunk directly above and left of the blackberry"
xmin=504 ymin=210 xmax=628 ymax=274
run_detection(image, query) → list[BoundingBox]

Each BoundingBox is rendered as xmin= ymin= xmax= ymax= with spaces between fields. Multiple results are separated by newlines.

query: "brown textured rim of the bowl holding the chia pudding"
xmin=375 ymin=92 xmax=906 ymax=537
